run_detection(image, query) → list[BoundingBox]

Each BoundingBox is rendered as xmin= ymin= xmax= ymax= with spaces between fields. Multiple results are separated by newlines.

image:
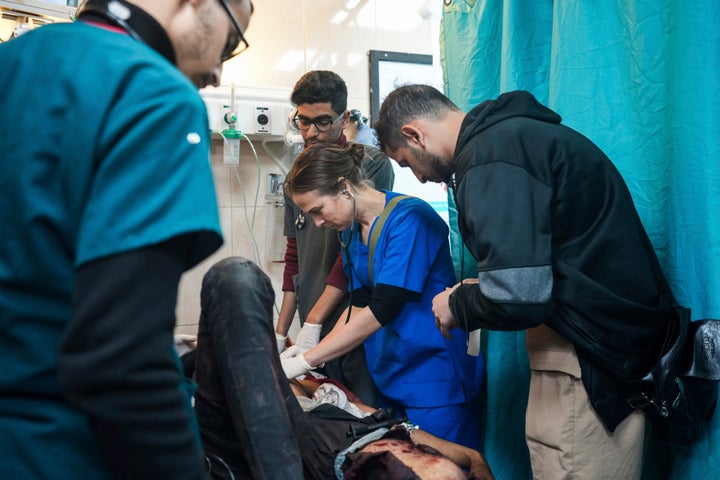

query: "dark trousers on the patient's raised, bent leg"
xmin=195 ymin=257 xmax=362 ymax=480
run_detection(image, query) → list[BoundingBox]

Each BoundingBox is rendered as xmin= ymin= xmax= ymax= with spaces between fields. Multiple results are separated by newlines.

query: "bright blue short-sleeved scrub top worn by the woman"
xmin=343 ymin=192 xmax=484 ymax=407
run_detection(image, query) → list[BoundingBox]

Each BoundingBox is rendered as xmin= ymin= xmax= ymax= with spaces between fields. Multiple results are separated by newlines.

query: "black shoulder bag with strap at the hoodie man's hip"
xmin=628 ymin=239 xmax=720 ymax=448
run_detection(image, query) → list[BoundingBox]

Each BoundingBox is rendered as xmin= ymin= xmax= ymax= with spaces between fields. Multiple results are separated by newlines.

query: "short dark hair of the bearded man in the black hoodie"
xmin=374 ymin=85 xmax=460 ymax=151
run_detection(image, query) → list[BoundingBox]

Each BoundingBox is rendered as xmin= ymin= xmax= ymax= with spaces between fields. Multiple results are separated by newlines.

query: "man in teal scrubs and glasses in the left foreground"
xmin=0 ymin=0 xmax=252 ymax=480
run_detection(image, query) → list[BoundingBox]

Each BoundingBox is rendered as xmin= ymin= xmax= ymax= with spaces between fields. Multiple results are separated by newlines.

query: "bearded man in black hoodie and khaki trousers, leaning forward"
xmin=375 ymin=85 xmax=670 ymax=479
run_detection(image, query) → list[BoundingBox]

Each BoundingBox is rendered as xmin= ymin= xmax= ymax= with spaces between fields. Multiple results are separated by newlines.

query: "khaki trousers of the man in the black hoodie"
xmin=525 ymin=325 xmax=645 ymax=480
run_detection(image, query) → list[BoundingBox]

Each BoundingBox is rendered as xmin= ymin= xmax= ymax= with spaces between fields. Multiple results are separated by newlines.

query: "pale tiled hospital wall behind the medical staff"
xmin=176 ymin=0 xmax=442 ymax=335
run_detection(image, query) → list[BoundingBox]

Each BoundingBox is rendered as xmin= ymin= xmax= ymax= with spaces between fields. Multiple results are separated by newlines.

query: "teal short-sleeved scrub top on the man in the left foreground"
xmin=0 ymin=22 xmax=222 ymax=479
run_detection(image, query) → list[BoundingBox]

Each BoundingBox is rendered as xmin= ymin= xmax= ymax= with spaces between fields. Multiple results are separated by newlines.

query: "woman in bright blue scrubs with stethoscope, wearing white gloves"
xmin=281 ymin=144 xmax=485 ymax=448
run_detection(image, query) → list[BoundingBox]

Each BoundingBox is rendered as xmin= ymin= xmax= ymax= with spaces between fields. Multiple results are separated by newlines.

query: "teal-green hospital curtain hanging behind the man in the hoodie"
xmin=440 ymin=0 xmax=720 ymax=479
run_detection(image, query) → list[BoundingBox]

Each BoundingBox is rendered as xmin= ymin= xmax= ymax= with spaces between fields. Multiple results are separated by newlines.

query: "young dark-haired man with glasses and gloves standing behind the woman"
xmin=276 ymin=70 xmax=395 ymax=406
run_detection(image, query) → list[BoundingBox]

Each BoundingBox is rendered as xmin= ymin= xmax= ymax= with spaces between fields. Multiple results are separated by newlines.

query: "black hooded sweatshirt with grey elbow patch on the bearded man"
xmin=450 ymin=91 xmax=671 ymax=431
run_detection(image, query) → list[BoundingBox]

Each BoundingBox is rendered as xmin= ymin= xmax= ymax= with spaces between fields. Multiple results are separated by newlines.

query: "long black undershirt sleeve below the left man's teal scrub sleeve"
xmin=58 ymin=235 xmax=205 ymax=479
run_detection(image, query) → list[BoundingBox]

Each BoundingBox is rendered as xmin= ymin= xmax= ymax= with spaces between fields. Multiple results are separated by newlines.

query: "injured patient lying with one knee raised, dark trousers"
xmin=195 ymin=257 xmax=493 ymax=480
